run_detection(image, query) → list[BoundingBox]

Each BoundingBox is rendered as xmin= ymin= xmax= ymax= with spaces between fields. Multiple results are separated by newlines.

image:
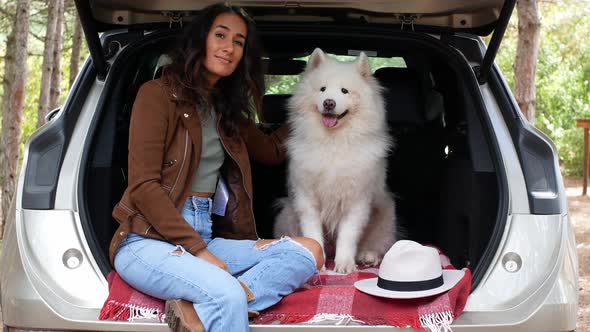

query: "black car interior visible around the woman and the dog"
xmin=83 ymin=31 xmax=499 ymax=274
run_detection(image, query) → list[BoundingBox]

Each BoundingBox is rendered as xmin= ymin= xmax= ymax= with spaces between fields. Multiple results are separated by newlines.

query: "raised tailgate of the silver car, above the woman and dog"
xmin=75 ymin=0 xmax=516 ymax=83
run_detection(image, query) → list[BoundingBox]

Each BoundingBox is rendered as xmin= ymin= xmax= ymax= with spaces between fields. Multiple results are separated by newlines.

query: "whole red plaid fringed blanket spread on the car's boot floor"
xmin=99 ymin=255 xmax=471 ymax=331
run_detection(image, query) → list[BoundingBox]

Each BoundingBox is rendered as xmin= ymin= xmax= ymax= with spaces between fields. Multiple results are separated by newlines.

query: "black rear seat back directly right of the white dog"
xmin=374 ymin=68 xmax=445 ymax=243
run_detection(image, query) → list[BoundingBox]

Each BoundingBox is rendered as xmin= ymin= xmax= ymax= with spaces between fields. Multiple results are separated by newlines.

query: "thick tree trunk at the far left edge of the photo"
xmin=0 ymin=0 xmax=31 ymax=239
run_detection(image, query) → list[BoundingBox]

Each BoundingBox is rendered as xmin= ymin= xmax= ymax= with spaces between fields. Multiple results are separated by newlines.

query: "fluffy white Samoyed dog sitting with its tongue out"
xmin=274 ymin=49 xmax=396 ymax=273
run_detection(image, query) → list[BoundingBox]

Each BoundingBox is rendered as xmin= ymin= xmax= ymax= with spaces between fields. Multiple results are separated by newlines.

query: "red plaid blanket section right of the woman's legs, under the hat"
xmin=253 ymin=255 xmax=471 ymax=331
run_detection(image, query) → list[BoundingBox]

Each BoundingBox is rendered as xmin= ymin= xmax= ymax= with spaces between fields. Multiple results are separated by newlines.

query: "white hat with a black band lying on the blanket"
xmin=354 ymin=240 xmax=465 ymax=299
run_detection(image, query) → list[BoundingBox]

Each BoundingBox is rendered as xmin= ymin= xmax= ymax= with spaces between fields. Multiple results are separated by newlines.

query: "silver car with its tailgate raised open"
xmin=0 ymin=0 xmax=578 ymax=332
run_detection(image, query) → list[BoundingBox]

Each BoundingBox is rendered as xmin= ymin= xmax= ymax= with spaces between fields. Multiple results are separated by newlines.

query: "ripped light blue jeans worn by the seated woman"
xmin=115 ymin=196 xmax=317 ymax=332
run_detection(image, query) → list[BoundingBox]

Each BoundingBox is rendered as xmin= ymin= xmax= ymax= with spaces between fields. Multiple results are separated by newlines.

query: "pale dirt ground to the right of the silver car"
xmin=0 ymin=179 xmax=590 ymax=331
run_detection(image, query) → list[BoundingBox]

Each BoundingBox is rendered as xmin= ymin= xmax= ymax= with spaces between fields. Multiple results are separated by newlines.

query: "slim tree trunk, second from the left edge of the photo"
xmin=37 ymin=0 xmax=59 ymax=128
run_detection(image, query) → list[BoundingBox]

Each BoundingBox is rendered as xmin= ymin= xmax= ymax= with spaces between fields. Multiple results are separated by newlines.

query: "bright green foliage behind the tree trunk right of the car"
xmin=496 ymin=0 xmax=590 ymax=176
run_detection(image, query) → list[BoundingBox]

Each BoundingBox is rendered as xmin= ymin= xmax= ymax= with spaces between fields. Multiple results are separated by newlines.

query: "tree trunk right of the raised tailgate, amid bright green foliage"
xmin=514 ymin=0 xmax=541 ymax=124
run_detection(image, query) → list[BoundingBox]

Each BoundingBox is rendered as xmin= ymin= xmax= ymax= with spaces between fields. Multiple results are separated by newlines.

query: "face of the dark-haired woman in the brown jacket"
xmin=203 ymin=13 xmax=248 ymax=86
